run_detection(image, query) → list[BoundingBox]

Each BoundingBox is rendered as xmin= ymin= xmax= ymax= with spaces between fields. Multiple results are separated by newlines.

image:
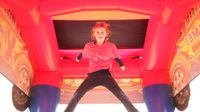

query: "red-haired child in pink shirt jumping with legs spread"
xmin=65 ymin=22 xmax=138 ymax=112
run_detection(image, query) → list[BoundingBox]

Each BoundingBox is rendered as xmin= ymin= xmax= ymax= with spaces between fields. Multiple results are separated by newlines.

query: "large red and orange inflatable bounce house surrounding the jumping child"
xmin=0 ymin=0 xmax=200 ymax=112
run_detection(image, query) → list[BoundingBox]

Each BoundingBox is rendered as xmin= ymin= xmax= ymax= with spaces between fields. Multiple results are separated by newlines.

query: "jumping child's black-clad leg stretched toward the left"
xmin=64 ymin=75 xmax=98 ymax=112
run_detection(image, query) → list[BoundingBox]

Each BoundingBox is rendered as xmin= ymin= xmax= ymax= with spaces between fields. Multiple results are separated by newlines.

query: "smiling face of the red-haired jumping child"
xmin=94 ymin=27 xmax=107 ymax=45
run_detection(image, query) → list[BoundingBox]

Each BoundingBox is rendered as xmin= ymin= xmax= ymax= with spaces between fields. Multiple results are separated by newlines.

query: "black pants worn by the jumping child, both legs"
xmin=65 ymin=69 xmax=138 ymax=112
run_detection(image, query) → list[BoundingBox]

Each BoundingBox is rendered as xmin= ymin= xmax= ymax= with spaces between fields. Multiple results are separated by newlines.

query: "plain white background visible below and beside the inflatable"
xmin=0 ymin=74 xmax=200 ymax=112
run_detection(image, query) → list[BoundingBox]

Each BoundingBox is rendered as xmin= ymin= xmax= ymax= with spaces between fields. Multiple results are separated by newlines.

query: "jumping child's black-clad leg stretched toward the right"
xmin=102 ymin=73 xmax=138 ymax=112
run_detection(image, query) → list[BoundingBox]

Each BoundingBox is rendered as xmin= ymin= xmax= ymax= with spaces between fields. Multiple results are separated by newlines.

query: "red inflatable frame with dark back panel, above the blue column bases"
xmin=0 ymin=0 xmax=200 ymax=103
